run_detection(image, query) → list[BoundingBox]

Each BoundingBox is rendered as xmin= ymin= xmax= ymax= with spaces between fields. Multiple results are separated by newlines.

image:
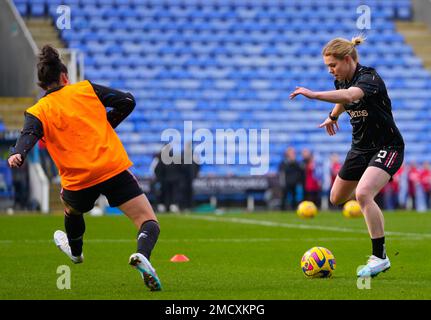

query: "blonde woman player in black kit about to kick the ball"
xmin=290 ymin=37 xmax=404 ymax=277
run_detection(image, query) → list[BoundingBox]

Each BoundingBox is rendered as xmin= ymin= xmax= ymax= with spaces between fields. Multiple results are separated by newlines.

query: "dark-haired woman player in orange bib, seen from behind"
xmin=8 ymin=46 xmax=161 ymax=291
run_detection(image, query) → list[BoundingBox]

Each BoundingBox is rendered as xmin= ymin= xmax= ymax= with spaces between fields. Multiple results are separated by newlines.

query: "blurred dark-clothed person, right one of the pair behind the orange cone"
xmin=180 ymin=142 xmax=199 ymax=210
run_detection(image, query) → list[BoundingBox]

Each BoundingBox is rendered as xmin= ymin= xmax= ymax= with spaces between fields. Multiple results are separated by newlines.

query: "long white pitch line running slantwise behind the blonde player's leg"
xmin=183 ymin=215 xmax=431 ymax=238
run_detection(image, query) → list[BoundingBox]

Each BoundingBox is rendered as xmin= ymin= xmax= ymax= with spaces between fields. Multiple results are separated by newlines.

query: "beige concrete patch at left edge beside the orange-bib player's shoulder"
xmin=0 ymin=97 xmax=35 ymax=130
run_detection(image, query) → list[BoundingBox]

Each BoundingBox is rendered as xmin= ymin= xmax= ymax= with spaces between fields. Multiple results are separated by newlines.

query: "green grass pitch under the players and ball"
xmin=0 ymin=212 xmax=431 ymax=300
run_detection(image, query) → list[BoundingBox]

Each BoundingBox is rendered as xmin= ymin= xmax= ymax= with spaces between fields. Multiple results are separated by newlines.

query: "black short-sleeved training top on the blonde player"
xmin=334 ymin=63 xmax=404 ymax=151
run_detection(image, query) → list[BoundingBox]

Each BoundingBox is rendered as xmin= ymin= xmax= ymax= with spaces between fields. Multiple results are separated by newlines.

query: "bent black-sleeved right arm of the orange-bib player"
xmin=91 ymin=83 xmax=136 ymax=129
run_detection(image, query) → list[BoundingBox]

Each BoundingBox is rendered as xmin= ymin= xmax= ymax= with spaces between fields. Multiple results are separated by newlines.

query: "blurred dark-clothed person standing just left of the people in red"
xmin=278 ymin=147 xmax=304 ymax=210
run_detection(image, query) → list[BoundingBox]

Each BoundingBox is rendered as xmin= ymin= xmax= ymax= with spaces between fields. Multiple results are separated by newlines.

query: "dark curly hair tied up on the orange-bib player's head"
xmin=37 ymin=45 xmax=67 ymax=90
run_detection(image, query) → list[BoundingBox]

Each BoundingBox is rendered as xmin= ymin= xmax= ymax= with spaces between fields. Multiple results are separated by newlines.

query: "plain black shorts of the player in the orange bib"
xmin=61 ymin=170 xmax=144 ymax=213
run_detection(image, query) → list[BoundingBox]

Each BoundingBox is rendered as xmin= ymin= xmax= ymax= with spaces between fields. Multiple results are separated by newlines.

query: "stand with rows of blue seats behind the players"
xmin=11 ymin=0 xmax=431 ymax=180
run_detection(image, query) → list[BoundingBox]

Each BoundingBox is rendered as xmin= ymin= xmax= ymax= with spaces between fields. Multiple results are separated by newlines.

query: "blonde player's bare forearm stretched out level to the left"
xmin=289 ymin=87 xmax=364 ymax=104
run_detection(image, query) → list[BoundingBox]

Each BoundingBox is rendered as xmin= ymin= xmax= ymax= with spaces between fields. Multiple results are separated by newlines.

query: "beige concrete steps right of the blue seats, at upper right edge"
xmin=396 ymin=21 xmax=431 ymax=70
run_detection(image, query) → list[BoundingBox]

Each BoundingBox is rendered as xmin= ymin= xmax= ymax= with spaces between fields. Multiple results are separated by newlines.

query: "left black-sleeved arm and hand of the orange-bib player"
xmin=8 ymin=112 xmax=43 ymax=168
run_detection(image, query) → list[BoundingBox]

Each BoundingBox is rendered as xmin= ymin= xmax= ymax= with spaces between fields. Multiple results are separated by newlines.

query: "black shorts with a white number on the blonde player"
xmin=338 ymin=147 xmax=404 ymax=181
